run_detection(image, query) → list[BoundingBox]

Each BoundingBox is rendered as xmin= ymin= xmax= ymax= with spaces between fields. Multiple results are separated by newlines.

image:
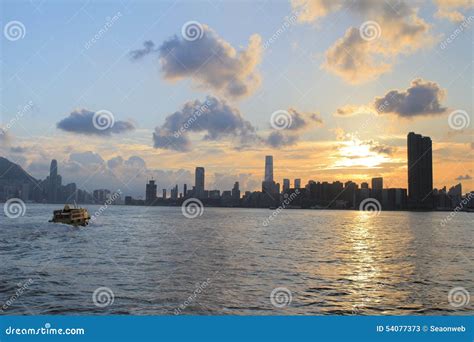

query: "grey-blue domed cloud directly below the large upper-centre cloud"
xmin=153 ymin=96 xmax=258 ymax=151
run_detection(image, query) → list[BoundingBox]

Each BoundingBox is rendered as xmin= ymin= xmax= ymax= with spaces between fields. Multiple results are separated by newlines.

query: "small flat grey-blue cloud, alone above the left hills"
xmin=57 ymin=109 xmax=135 ymax=136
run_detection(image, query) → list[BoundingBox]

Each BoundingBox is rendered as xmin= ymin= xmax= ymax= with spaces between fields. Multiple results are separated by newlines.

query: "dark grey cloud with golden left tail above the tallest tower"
xmin=335 ymin=79 xmax=447 ymax=118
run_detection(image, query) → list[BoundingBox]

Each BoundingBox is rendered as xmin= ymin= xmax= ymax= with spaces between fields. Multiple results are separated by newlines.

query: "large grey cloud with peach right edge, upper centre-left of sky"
xmin=132 ymin=25 xmax=262 ymax=98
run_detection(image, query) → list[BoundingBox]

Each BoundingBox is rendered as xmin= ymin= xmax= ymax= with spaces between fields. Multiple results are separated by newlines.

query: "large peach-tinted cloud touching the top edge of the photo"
xmin=292 ymin=0 xmax=432 ymax=84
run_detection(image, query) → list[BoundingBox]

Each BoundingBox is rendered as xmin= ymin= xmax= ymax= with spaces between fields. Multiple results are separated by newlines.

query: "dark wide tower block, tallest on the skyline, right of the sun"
xmin=407 ymin=132 xmax=433 ymax=209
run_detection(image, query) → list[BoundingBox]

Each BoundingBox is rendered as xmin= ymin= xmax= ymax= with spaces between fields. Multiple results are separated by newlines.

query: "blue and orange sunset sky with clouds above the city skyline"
xmin=0 ymin=0 xmax=474 ymax=197
